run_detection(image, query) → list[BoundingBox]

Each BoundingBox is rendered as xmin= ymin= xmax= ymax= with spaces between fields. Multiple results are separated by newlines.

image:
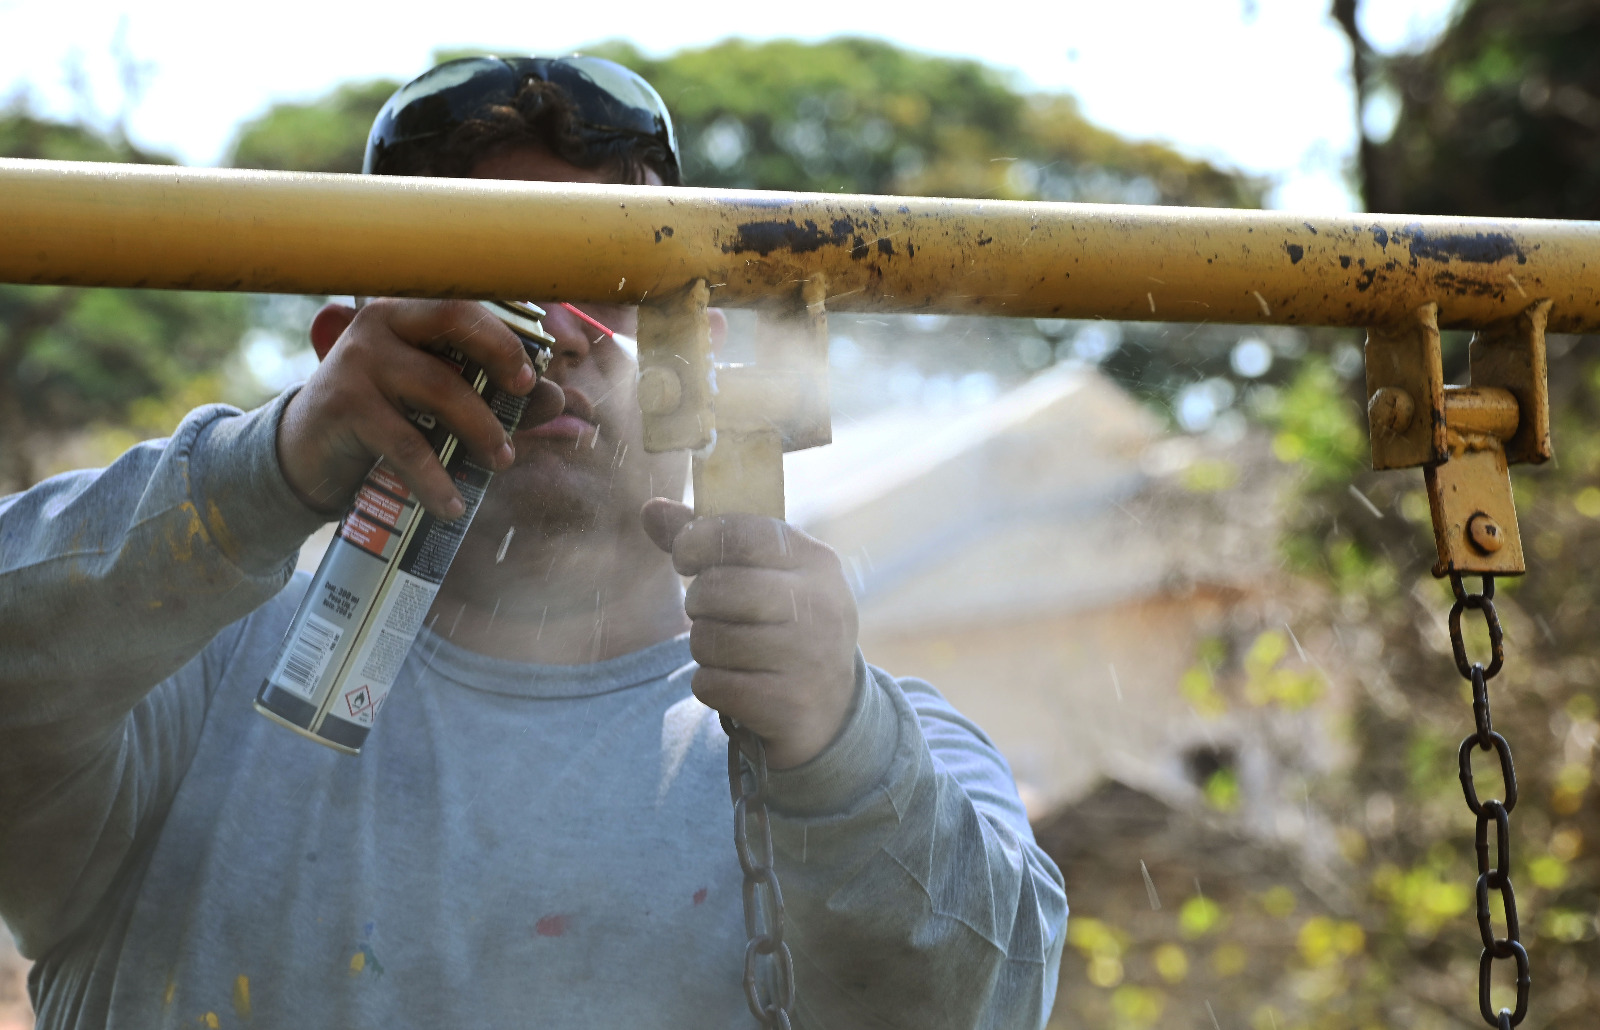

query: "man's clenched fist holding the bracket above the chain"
xmin=640 ymin=497 xmax=858 ymax=769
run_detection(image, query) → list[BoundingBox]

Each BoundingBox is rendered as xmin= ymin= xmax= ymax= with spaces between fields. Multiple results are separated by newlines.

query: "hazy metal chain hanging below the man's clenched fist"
xmin=722 ymin=715 xmax=795 ymax=1030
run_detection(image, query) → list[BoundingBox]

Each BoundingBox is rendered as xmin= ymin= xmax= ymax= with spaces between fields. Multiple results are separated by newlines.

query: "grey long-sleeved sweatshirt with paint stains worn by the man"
xmin=0 ymin=398 xmax=1067 ymax=1030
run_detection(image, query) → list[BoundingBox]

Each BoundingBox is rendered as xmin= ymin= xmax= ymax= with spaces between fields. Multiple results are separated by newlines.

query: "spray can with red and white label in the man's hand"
xmin=256 ymin=301 xmax=555 ymax=755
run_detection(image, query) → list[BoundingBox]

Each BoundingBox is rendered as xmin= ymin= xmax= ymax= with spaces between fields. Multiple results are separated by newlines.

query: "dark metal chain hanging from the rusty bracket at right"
xmin=1450 ymin=573 xmax=1533 ymax=1030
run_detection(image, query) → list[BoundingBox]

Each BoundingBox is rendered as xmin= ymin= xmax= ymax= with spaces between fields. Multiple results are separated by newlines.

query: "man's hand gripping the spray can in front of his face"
xmin=278 ymin=299 xmax=563 ymax=518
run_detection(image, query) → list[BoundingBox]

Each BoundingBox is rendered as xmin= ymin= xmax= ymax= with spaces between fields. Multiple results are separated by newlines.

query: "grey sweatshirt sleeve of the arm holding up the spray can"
xmin=0 ymin=395 xmax=323 ymax=955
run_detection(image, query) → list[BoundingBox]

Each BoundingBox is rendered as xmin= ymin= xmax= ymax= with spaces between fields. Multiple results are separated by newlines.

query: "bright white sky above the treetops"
xmin=0 ymin=0 xmax=1454 ymax=211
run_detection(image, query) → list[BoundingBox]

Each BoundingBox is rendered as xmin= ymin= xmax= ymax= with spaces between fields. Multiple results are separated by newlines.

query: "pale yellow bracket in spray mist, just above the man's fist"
xmin=638 ymin=273 xmax=832 ymax=518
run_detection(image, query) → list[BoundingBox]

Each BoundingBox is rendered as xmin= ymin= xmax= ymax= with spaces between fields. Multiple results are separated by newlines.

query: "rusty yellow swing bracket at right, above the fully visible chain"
xmin=1366 ymin=301 xmax=1552 ymax=576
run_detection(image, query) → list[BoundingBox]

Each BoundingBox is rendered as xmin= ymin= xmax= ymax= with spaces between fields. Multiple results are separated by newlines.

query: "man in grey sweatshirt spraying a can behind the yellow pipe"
xmin=0 ymin=58 xmax=1066 ymax=1027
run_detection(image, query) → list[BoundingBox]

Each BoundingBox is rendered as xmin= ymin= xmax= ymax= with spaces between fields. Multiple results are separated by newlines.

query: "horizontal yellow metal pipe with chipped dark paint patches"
xmin=0 ymin=160 xmax=1600 ymax=333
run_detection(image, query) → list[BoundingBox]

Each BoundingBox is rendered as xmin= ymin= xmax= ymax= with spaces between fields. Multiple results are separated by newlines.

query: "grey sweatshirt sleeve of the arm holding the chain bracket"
xmin=770 ymin=654 xmax=1067 ymax=1028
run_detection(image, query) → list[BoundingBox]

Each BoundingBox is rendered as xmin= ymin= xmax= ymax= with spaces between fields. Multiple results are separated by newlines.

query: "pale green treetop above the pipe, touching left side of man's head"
xmin=229 ymin=78 xmax=400 ymax=173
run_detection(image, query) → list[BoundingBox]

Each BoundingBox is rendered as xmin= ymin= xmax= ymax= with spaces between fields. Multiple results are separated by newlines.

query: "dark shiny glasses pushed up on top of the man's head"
xmin=362 ymin=56 xmax=680 ymax=179
